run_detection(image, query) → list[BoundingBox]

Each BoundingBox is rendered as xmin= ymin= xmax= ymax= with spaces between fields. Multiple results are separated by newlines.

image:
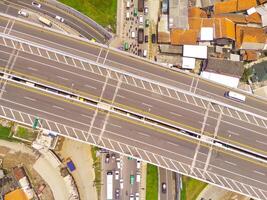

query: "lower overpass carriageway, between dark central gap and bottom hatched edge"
xmin=0 ymin=82 xmax=267 ymax=200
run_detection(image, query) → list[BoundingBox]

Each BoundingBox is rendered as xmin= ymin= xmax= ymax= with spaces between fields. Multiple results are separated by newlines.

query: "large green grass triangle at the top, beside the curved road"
xmin=60 ymin=0 xmax=117 ymax=32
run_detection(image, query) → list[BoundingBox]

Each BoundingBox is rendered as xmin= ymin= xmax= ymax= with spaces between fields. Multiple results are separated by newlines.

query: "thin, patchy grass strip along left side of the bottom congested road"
xmin=91 ymin=146 xmax=102 ymax=199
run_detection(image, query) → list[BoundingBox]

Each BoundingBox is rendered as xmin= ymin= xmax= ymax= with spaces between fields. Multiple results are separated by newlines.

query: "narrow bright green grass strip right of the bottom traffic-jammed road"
xmin=146 ymin=164 xmax=158 ymax=200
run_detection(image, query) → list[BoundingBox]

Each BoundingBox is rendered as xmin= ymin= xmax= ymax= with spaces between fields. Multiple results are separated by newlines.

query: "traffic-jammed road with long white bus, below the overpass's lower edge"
xmin=101 ymin=151 xmax=141 ymax=200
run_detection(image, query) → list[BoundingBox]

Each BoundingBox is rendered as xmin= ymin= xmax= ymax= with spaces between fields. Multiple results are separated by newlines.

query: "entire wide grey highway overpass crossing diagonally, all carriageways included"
xmin=0 ymin=13 xmax=267 ymax=199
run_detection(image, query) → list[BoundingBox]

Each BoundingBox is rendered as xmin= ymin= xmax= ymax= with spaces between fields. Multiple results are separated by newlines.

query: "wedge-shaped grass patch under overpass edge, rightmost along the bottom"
xmin=181 ymin=176 xmax=208 ymax=200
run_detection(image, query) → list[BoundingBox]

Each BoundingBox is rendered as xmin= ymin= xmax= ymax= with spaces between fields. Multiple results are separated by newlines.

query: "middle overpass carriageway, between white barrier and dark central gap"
xmin=0 ymin=36 xmax=267 ymax=159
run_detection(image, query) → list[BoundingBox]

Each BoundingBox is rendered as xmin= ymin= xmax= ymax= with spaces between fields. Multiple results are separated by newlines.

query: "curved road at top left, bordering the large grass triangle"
xmin=0 ymin=0 xmax=111 ymax=44
